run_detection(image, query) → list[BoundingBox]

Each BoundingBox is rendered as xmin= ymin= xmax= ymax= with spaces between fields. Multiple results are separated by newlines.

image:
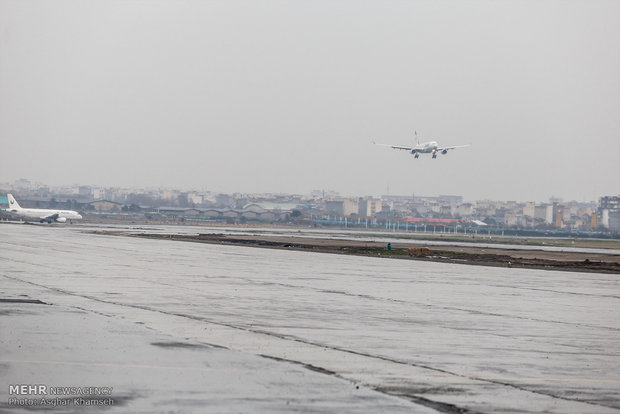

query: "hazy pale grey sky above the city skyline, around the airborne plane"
xmin=0 ymin=0 xmax=620 ymax=201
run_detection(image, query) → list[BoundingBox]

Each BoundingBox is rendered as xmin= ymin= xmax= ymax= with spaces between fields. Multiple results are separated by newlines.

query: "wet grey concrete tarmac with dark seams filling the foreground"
xmin=0 ymin=225 xmax=620 ymax=413
